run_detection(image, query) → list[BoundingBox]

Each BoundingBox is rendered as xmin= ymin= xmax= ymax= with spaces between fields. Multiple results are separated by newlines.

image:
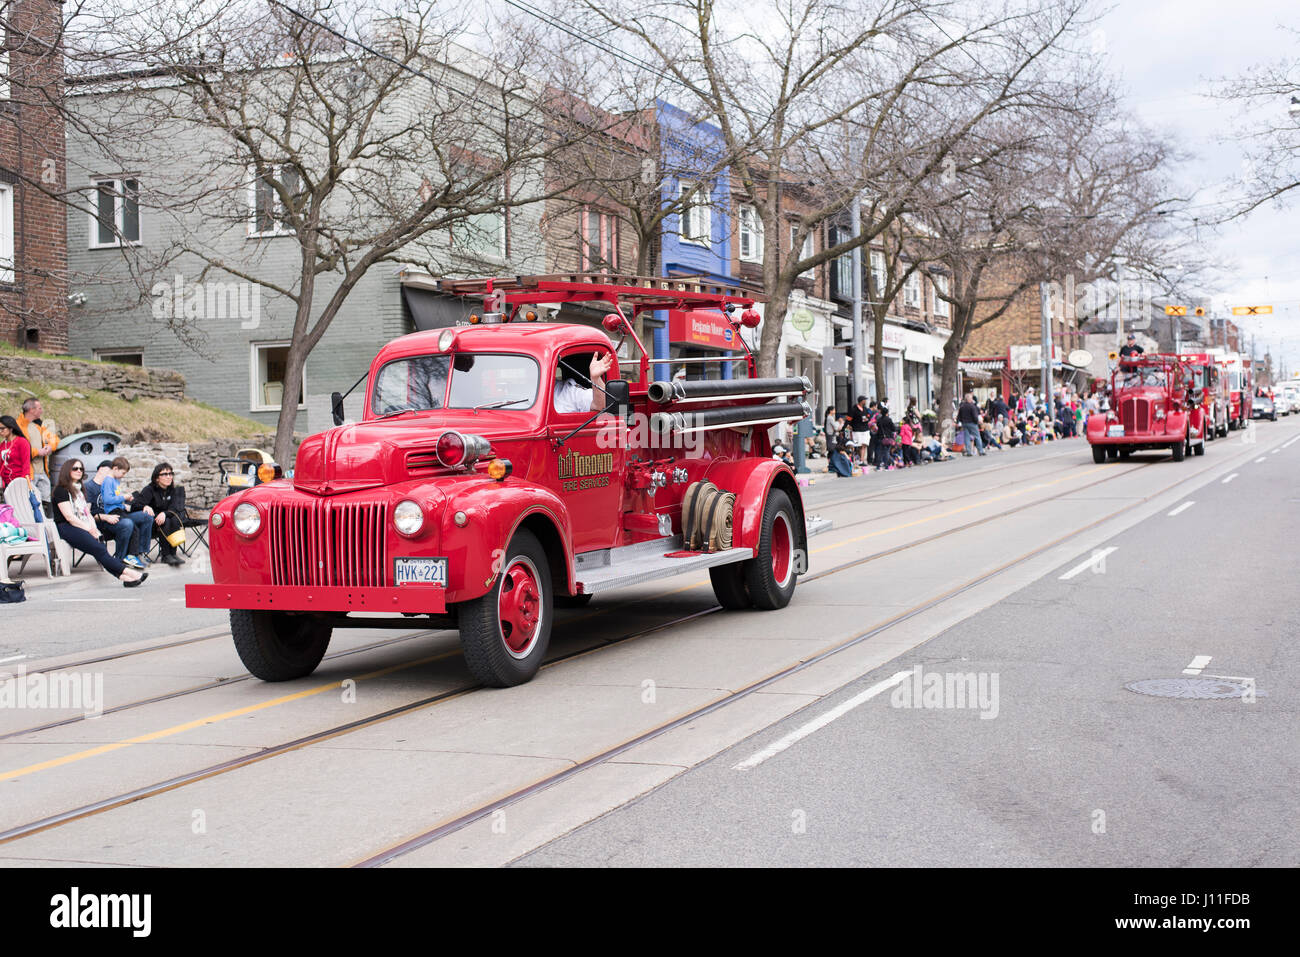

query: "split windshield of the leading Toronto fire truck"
xmin=371 ymin=352 xmax=541 ymax=416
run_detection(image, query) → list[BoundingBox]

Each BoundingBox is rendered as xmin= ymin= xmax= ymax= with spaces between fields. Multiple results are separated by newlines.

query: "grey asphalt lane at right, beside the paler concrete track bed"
xmin=520 ymin=432 xmax=1300 ymax=867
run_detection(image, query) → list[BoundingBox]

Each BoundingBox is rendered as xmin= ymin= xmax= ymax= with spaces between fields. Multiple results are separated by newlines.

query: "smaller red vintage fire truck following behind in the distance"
xmin=1088 ymin=354 xmax=1205 ymax=464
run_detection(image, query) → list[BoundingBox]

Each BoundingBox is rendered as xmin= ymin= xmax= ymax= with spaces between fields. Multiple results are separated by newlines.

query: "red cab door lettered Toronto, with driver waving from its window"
xmin=547 ymin=346 xmax=627 ymax=553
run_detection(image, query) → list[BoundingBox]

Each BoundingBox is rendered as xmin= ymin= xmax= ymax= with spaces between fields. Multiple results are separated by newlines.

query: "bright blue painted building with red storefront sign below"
xmin=654 ymin=100 xmax=737 ymax=378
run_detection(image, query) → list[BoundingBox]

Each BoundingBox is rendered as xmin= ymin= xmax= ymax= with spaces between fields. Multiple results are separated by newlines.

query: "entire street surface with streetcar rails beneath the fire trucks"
xmin=0 ymin=421 xmax=1300 ymax=867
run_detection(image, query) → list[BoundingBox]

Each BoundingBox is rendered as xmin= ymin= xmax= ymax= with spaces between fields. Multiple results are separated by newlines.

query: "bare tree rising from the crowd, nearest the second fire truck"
xmin=919 ymin=94 xmax=1177 ymax=421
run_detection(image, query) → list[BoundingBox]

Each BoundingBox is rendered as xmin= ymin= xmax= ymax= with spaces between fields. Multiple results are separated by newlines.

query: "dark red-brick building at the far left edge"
xmin=0 ymin=0 xmax=68 ymax=352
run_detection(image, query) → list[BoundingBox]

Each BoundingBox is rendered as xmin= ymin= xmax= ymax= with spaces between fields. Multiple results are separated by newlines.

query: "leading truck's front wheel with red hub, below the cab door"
xmin=459 ymin=531 xmax=554 ymax=688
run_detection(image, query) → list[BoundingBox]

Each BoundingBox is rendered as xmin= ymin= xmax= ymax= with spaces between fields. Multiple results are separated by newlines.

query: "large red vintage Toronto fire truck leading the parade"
xmin=186 ymin=276 xmax=829 ymax=687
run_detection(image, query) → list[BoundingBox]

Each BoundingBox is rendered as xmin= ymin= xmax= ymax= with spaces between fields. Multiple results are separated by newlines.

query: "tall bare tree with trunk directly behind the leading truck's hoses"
xmin=548 ymin=0 xmax=1097 ymax=374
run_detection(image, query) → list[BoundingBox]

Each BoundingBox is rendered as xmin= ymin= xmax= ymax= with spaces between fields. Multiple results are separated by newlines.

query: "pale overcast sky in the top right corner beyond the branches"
xmin=1095 ymin=0 xmax=1300 ymax=369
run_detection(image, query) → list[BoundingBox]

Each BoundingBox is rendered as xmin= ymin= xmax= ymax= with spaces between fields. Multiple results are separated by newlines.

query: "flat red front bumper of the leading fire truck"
xmin=185 ymin=585 xmax=447 ymax=615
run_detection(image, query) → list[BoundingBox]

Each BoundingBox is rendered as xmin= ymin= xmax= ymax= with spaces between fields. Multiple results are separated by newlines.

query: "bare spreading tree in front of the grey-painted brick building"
xmin=64 ymin=0 xmax=613 ymax=462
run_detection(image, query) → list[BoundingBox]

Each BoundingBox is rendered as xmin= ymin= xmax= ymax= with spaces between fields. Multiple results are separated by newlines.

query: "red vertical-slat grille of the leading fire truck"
xmin=270 ymin=498 xmax=387 ymax=588
